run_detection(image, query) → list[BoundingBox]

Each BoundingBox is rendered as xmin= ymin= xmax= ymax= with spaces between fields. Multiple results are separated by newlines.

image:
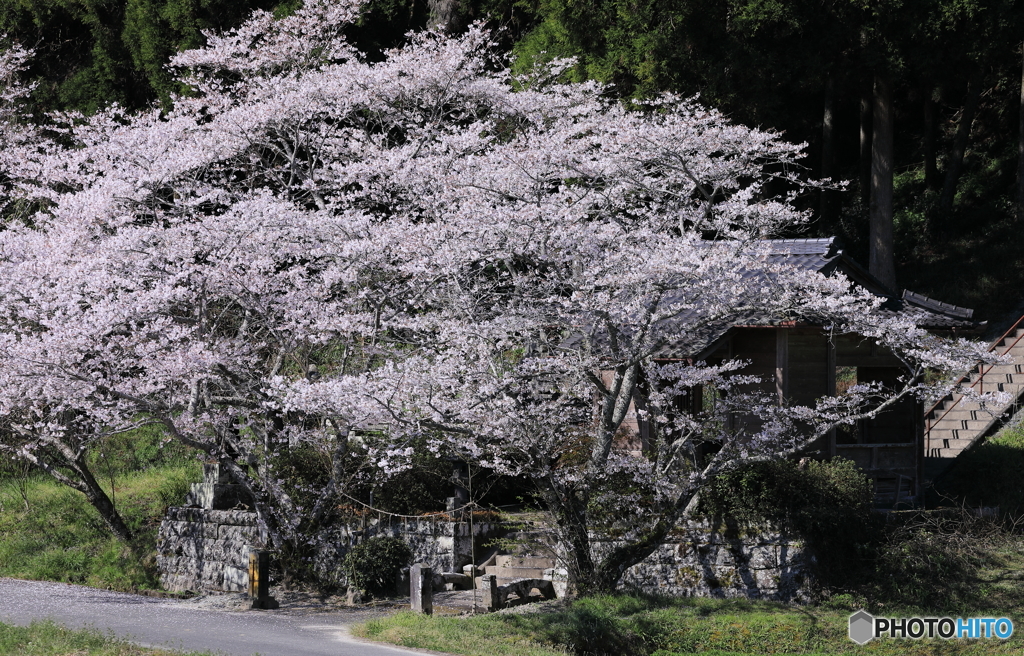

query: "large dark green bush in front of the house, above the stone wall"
xmin=698 ymin=458 xmax=881 ymax=586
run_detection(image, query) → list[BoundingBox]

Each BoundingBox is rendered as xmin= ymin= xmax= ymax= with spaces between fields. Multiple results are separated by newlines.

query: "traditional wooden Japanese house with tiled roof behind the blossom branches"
xmin=610 ymin=238 xmax=983 ymax=507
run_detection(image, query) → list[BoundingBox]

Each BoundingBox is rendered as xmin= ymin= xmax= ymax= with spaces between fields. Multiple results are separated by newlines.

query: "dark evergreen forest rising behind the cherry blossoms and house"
xmin=8 ymin=0 xmax=1024 ymax=324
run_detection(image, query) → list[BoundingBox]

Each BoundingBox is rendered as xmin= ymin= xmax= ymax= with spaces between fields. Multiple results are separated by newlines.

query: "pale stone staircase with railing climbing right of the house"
xmin=925 ymin=317 xmax=1024 ymax=479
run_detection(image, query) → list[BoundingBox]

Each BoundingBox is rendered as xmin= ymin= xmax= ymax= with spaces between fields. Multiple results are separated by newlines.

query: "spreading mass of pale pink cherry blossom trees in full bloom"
xmin=0 ymin=1 xmax=995 ymax=592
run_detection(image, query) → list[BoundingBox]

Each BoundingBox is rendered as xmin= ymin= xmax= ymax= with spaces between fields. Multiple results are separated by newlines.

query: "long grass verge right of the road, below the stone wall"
xmin=353 ymin=596 xmax=1024 ymax=656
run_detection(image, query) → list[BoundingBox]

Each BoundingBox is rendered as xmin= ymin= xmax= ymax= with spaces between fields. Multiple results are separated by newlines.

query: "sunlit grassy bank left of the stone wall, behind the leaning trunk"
xmin=0 ymin=461 xmax=201 ymax=591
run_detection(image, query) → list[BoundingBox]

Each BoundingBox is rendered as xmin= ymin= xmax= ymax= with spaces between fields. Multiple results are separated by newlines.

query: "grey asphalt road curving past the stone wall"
xmin=0 ymin=578 xmax=423 ymax=656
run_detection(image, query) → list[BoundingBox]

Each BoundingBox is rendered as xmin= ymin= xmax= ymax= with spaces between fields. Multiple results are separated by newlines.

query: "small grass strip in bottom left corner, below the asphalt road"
xmin=0 ymin=622 xmax=210 ymax=656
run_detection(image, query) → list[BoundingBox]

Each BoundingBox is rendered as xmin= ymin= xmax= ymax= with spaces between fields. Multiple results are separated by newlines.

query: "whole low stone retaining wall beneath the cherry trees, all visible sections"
xmin=157 ymin=466 xmax=810 ymax=601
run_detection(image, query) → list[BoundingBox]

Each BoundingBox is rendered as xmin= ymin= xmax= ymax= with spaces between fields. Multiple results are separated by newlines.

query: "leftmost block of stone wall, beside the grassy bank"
xmin=157 ymin=508 xmax=266 ymax=592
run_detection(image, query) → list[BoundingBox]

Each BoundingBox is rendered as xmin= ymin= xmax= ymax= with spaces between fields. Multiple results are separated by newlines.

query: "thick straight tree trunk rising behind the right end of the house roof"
xmin=867 ymin=69 xmax=896 ymax=291
